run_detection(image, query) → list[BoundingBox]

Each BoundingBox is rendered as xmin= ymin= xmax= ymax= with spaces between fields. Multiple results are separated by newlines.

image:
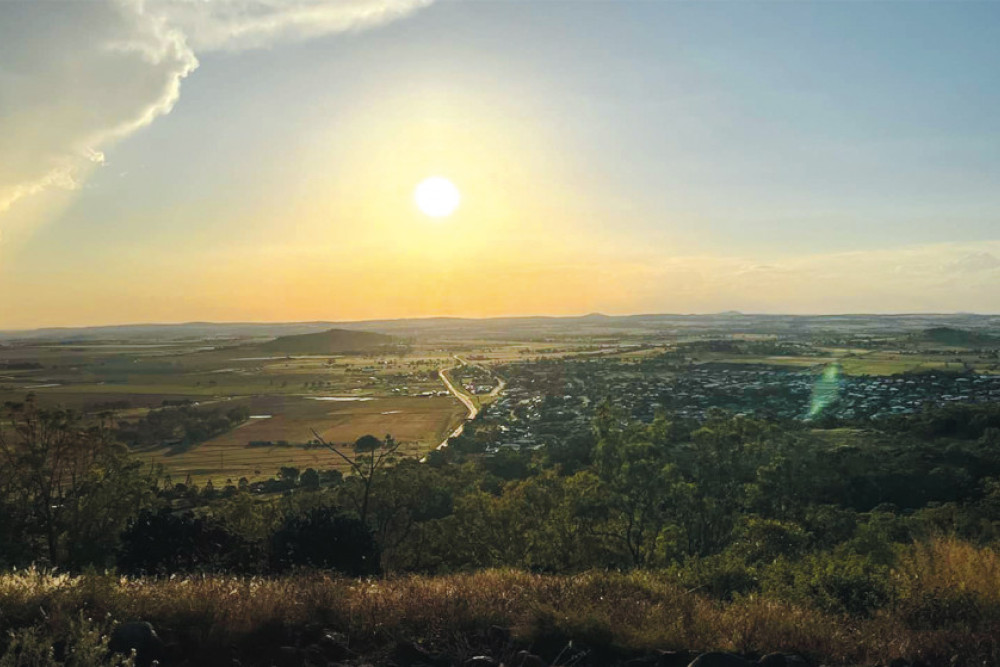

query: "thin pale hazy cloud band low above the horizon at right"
xmin=596 ymin=241 xmax=1000 ymax=313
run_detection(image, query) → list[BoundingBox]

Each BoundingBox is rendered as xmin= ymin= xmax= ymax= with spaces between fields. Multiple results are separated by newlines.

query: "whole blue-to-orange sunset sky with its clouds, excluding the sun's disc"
xmin=0 ymin=0 xmax=1000 ymax=329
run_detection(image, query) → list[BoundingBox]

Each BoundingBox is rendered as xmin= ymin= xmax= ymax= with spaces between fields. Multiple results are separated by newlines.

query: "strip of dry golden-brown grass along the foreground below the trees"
xmin=0 ymin=540 xmax=1000 ymax=665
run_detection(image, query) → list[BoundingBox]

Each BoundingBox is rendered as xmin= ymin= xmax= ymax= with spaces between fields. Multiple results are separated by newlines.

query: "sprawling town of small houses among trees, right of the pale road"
xmin=477 ymin=354 xmax=1000 ymax=453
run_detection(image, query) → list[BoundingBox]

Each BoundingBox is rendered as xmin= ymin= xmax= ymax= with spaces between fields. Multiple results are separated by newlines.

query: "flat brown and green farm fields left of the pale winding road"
xmin=0 ymin=339 xmax=484 ymax=482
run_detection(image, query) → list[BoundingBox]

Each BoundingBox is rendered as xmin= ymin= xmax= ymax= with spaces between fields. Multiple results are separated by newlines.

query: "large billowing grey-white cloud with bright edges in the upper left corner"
xmin=0 ymin=0 xmax=430 ymax=214
